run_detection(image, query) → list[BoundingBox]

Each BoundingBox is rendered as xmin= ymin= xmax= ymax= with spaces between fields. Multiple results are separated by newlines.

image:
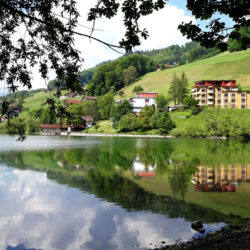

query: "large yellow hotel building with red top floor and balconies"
xmin=192 ymin=80 xmax=250 ymax=109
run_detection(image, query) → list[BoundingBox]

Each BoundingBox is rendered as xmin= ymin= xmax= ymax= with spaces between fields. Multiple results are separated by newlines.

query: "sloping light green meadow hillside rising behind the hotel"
xmin=117 ymin=49 xmax=250 ymax=99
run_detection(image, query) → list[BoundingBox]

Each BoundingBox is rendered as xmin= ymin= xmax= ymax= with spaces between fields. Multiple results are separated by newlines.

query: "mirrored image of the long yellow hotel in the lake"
xmin=192 ymin=164 xmax=250 ymax=192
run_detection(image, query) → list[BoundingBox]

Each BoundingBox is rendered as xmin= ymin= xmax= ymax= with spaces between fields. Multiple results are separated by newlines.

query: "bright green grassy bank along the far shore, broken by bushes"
xmin=83 ymin=109 xmax=250 ymax=138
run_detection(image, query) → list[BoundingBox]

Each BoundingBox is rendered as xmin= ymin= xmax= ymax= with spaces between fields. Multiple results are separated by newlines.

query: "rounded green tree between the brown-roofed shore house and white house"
xmin=98 ymin=93 xmax=115 ymax=120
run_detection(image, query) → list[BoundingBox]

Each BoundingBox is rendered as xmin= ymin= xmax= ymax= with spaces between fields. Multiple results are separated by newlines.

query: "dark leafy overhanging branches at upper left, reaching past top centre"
xmin=0 ymin=0 xmax=165 ymax=94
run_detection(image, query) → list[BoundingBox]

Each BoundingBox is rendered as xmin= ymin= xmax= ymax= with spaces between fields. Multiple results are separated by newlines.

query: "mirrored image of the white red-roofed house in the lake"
xmin=133 ymin=156 xmax=156 ymax=178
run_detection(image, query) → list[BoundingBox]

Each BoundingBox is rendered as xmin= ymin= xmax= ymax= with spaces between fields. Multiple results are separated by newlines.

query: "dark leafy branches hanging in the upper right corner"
xmin=178 ymin=0 xmax=250 ymax=51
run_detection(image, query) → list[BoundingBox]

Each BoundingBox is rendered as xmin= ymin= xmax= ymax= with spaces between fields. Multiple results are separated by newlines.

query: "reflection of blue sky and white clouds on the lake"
xmin=0 ymin=164 xmax=223 ymax=250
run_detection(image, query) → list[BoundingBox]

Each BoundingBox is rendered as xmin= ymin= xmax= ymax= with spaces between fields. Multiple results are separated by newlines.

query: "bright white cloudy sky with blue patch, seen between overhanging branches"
xmin=0 ymin=0 xmax=234 ymax=92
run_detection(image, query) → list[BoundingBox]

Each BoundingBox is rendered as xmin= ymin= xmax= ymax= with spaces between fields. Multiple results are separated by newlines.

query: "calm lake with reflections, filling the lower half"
xmin=0 ymin=136 xmax=250 ymax=250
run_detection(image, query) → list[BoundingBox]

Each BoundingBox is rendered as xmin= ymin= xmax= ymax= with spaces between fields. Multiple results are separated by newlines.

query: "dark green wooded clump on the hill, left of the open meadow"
xmin=87 ymin=55 xmax=153 ymax=96
